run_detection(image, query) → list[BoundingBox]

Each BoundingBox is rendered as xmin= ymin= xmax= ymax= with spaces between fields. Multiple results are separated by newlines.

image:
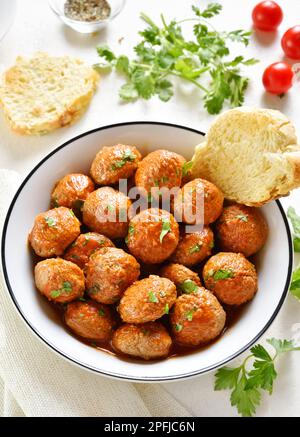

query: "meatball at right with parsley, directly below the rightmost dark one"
xmin=203 ymin=252 xmax=257 ymax=305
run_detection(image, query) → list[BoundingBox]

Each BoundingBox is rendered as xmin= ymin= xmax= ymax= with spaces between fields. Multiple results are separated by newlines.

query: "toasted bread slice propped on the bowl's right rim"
xmin=191 ymin=107 xmax=300 ymax=206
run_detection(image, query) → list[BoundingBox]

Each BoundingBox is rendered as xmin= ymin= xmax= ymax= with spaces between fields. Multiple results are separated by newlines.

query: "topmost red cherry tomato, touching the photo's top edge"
xmin=252 ymin=1 xmax=283 ymax=32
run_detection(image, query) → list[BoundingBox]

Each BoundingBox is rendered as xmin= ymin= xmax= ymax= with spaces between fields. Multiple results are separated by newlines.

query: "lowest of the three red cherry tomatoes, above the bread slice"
xmin=263 ymin=62 xmax=294 ymax=95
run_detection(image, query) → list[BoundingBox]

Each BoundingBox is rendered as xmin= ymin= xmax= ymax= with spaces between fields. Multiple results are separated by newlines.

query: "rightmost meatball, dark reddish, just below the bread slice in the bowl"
xmin=216 ymin=204 xmax=268 ymax=257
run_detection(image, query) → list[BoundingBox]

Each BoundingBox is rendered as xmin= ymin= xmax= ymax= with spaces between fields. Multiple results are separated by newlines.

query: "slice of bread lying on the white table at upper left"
xmin=0 ymin=53 xmax=99 ymax=135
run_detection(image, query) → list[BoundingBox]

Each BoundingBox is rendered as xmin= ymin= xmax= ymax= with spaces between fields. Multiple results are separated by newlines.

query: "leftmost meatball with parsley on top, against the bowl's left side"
xmin=28 ymin=206 xmax=80 ymax=258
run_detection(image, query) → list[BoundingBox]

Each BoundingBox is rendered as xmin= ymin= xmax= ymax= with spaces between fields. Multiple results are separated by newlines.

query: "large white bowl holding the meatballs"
xmin=2 ymin=122 xmax=293 ymax=382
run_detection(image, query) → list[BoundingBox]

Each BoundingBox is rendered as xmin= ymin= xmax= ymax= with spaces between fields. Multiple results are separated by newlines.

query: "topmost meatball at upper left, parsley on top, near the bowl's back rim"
xmin=90 ymin=144 xmax=142 ymax=185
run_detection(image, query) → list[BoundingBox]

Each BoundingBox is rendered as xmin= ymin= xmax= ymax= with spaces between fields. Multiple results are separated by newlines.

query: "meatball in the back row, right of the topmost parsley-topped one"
xmin=135 ymin=150 xmax=186 ymax=192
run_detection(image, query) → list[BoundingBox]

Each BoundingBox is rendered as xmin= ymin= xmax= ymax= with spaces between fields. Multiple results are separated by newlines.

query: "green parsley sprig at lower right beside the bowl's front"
xmin=215 ymin=338 xmax=300 ymax=416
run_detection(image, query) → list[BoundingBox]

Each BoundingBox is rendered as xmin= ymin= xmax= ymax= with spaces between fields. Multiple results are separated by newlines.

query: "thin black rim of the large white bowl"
xmin=1 ymin=121 xmax=293 ymax=382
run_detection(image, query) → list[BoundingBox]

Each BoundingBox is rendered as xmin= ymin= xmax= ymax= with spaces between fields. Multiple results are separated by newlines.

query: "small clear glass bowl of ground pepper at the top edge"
xmin=48 ymin=0 xmax=126 ymax=33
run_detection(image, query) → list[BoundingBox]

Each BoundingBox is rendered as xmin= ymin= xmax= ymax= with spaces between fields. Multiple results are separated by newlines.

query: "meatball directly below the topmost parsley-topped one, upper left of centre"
xmin=83 ymin=187 xmax=131 ymax=238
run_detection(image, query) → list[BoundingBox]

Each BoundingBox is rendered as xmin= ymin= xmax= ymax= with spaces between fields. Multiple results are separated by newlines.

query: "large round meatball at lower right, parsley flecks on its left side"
xmin=170 ymin=288 xmax=226 ymax=346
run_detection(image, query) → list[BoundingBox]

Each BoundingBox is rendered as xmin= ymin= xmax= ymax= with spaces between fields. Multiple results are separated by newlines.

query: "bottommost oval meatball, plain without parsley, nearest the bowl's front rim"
xmin=112 ymin=322 xmax=172 ymax=360
